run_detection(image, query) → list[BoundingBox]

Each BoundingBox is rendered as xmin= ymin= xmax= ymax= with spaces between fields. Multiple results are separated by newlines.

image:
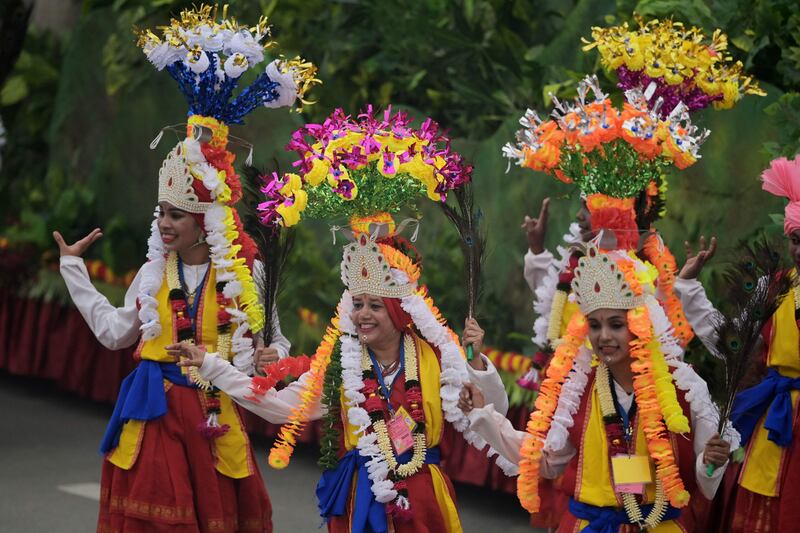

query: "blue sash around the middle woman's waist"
xmin=316 ymin=446 xmax=441 ymax=533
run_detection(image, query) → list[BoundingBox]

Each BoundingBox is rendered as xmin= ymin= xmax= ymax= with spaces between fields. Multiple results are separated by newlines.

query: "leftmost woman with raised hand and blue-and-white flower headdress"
xmin=49 ymin=6 xmax=318 ymax=533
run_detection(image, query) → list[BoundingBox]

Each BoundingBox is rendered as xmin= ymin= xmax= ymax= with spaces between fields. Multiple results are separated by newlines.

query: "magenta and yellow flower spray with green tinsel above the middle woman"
xmin=259 ymin=106 xmax=472 ymax=226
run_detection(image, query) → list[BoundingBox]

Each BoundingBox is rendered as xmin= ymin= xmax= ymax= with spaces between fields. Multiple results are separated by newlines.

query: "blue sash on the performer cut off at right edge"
xmin=731 ymin=368 xmax=800 ymax=448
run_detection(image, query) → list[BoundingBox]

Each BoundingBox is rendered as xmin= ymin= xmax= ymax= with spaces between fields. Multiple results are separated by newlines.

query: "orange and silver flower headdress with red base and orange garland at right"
xmin=503 ymin=76 xmax=708 ymax=344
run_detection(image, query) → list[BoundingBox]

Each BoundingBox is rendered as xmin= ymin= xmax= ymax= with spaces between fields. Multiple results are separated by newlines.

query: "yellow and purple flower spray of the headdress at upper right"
xmin=584 ymin=17 xmax=766 ymax=118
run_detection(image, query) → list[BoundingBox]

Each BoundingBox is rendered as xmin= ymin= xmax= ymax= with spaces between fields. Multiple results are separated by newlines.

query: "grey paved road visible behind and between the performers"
xmin=0 ymin=373 xmax=544 ymax=533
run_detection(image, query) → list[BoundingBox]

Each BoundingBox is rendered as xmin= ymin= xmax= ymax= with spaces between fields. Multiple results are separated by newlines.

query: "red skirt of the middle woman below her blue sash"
xmin=328 ymin=465 xmax=456 ymax=533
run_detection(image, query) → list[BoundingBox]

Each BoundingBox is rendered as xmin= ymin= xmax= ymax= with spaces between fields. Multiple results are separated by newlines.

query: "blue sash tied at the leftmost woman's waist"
xmin=100 ymin=359 xmax=194 ymax=454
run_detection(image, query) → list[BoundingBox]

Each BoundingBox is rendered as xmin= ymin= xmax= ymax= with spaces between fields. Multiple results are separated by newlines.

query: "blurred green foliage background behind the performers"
xmin=0 ymin=0 xmax=800 ymax=358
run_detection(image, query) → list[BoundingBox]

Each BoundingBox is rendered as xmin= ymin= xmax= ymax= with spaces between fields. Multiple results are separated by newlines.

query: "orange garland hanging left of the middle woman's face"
xmin=269 ymin=315 xmax=342 ymax=469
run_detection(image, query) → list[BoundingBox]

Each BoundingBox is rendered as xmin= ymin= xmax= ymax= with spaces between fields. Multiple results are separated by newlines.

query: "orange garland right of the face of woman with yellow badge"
xmin=628 ymin=307 xmax=689 ymax=508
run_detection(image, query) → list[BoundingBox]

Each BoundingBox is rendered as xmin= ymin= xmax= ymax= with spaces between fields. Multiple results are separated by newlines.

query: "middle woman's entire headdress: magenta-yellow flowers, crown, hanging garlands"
xmin=259 ymin=106 xmax=513 ymax=518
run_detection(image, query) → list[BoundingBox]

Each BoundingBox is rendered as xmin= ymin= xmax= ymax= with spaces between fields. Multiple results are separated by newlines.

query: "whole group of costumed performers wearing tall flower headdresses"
xmin=48 ymin=6 xmax=800 ymax=533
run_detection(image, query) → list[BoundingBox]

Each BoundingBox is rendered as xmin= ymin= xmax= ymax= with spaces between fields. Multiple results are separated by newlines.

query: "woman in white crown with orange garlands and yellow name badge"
xmin=460 ymin=245 xmax=738 ymax=533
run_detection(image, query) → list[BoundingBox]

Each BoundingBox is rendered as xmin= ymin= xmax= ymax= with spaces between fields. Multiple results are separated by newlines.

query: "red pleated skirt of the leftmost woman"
xmin=97 ymin=385 xmax=272 ymax=533
